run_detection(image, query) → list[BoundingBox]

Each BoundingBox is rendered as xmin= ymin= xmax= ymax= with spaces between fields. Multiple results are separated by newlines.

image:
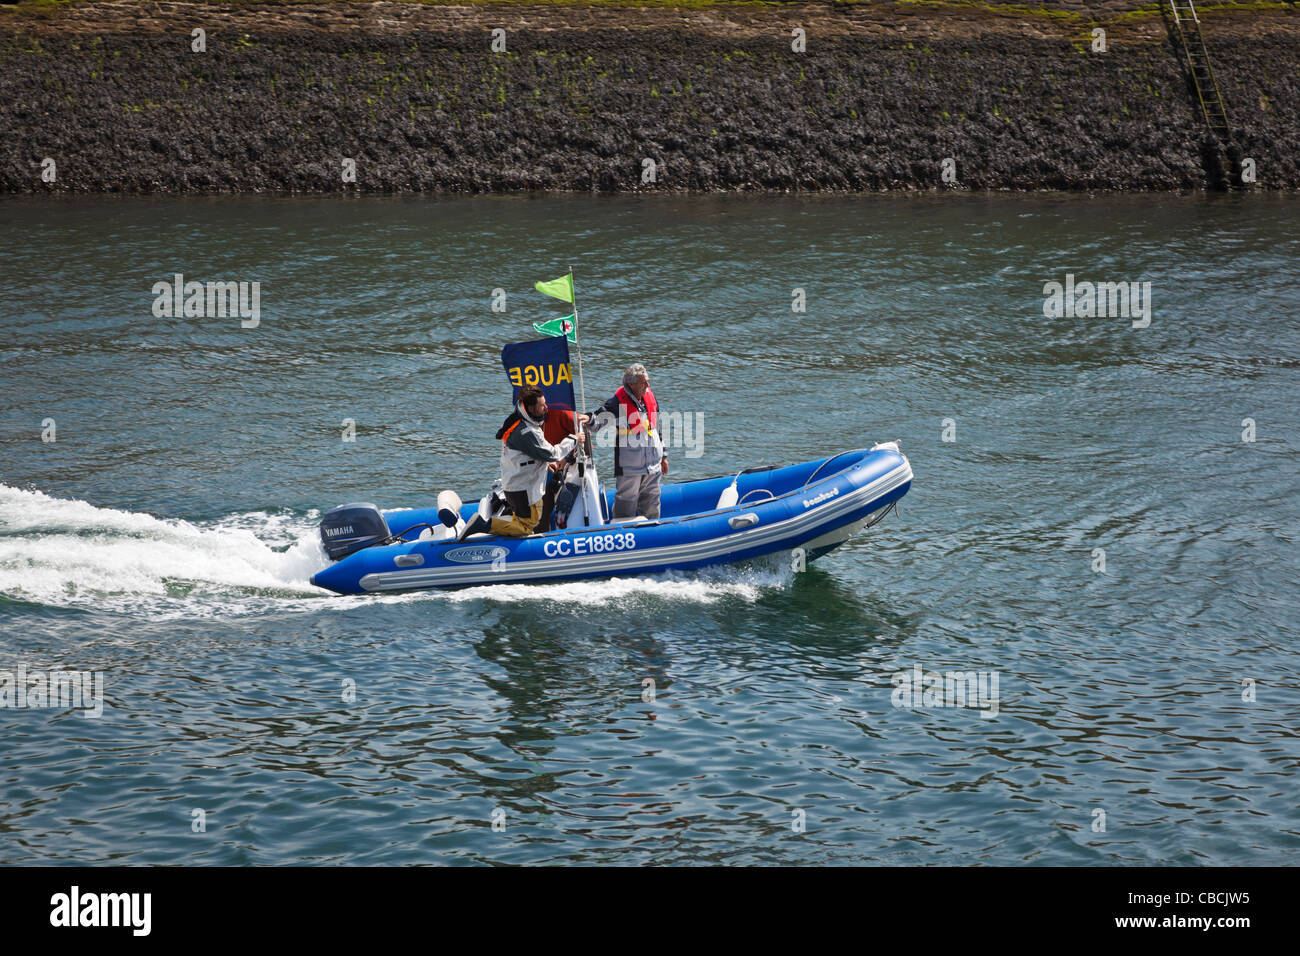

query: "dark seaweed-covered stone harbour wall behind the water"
xmin=0 ymin=0 xmax=1300 ymax=193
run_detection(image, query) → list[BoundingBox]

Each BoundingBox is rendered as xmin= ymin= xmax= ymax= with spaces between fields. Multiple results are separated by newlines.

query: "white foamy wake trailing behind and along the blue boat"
xmin=0 ymin=485 xmax=793 ymax=620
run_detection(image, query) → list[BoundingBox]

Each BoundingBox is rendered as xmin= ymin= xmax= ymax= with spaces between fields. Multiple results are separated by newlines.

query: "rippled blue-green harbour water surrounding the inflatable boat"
xmin=0 ymin=196 xmax=1300 ymax=864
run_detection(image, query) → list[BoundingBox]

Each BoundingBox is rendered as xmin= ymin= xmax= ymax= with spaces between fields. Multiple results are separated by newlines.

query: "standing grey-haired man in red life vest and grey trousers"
xmin=592 ymin=363 xmax=668 ymax=520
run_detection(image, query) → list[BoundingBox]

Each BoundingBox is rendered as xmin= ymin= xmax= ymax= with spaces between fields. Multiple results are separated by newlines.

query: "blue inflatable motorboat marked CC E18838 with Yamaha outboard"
xmin=312 ymin=442 xmax=911 ymax=594
